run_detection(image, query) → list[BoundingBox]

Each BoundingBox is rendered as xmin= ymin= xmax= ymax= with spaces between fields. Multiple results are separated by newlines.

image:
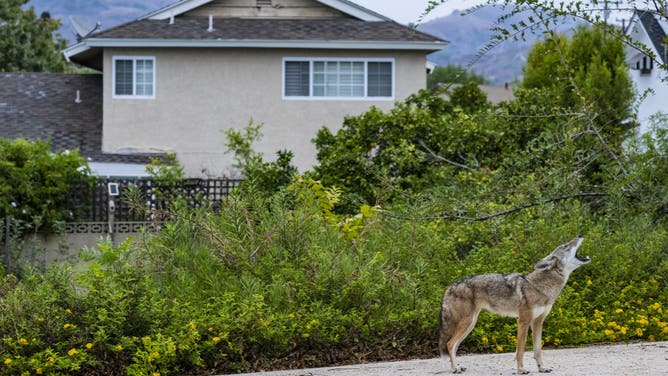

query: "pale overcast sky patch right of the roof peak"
xmin=351 ymin=0 xmax=482 ymax=24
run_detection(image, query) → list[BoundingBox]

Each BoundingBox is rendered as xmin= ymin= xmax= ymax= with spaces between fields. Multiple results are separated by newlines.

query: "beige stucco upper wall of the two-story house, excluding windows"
xmin=103 ymin=48 xmax=426 ymax=177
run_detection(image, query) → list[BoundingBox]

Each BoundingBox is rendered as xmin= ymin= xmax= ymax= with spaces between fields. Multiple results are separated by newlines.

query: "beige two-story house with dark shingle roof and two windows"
xmin=64 ymin=0 xmax=446 ymax=177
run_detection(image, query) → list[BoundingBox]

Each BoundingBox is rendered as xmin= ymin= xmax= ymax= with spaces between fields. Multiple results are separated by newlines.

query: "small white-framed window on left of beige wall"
xmin=113 ymin=56 xmax=155 ymax=98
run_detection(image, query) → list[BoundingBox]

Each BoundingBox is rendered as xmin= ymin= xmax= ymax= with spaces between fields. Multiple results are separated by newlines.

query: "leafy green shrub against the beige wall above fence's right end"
xmin=225 ymin=119 xmax=297 ymax=194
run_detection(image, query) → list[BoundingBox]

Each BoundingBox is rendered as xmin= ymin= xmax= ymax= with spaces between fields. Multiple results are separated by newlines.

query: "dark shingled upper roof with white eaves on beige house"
xmin=63 ymin=0 xmax=447 ymax=69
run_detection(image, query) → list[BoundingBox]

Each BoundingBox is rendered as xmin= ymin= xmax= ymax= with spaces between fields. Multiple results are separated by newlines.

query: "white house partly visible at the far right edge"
xmin=626 ymin=11 xmax=668 ymax=134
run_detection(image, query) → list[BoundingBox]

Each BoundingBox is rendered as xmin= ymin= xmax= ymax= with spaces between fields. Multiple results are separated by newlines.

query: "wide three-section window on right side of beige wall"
xmin=283 ymin=58 xmax=394 ymax=99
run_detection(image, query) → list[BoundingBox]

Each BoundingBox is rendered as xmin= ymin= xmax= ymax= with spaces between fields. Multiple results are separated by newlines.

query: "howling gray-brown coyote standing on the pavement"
xmin=438 ymin=236 xmax=591 ymax=375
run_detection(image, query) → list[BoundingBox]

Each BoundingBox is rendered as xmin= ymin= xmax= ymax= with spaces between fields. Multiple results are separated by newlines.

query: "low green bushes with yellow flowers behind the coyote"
xmin=0 ymin=179 xmax=668 ymax=375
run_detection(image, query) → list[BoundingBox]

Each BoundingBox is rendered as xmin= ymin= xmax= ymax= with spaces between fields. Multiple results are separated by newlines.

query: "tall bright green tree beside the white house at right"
xmin=521 ymin=25 xmax=634 ymax=142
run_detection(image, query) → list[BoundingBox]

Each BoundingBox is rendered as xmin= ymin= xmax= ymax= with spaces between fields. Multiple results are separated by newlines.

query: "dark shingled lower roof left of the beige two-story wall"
xmin=0 ymin=73 xmax=160 ymax=164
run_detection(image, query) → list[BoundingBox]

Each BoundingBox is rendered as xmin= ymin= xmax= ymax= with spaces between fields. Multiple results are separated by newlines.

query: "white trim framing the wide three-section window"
xmin=281 ymin=57 xmax=397 ymax=101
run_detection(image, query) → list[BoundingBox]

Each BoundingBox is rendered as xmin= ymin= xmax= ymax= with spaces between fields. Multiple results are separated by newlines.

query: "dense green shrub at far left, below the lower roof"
xmin=0 ymin=139 xmax=92 ymax=230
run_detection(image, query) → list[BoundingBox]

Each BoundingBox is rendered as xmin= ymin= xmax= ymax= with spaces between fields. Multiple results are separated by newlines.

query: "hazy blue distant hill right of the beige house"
xmin=418 ymin=7 xmax=575 ymax=85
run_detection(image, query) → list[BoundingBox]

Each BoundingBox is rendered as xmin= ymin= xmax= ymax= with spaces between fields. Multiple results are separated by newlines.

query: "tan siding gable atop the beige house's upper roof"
xmin=179 ymin=0 xmax=349 ymax=19
